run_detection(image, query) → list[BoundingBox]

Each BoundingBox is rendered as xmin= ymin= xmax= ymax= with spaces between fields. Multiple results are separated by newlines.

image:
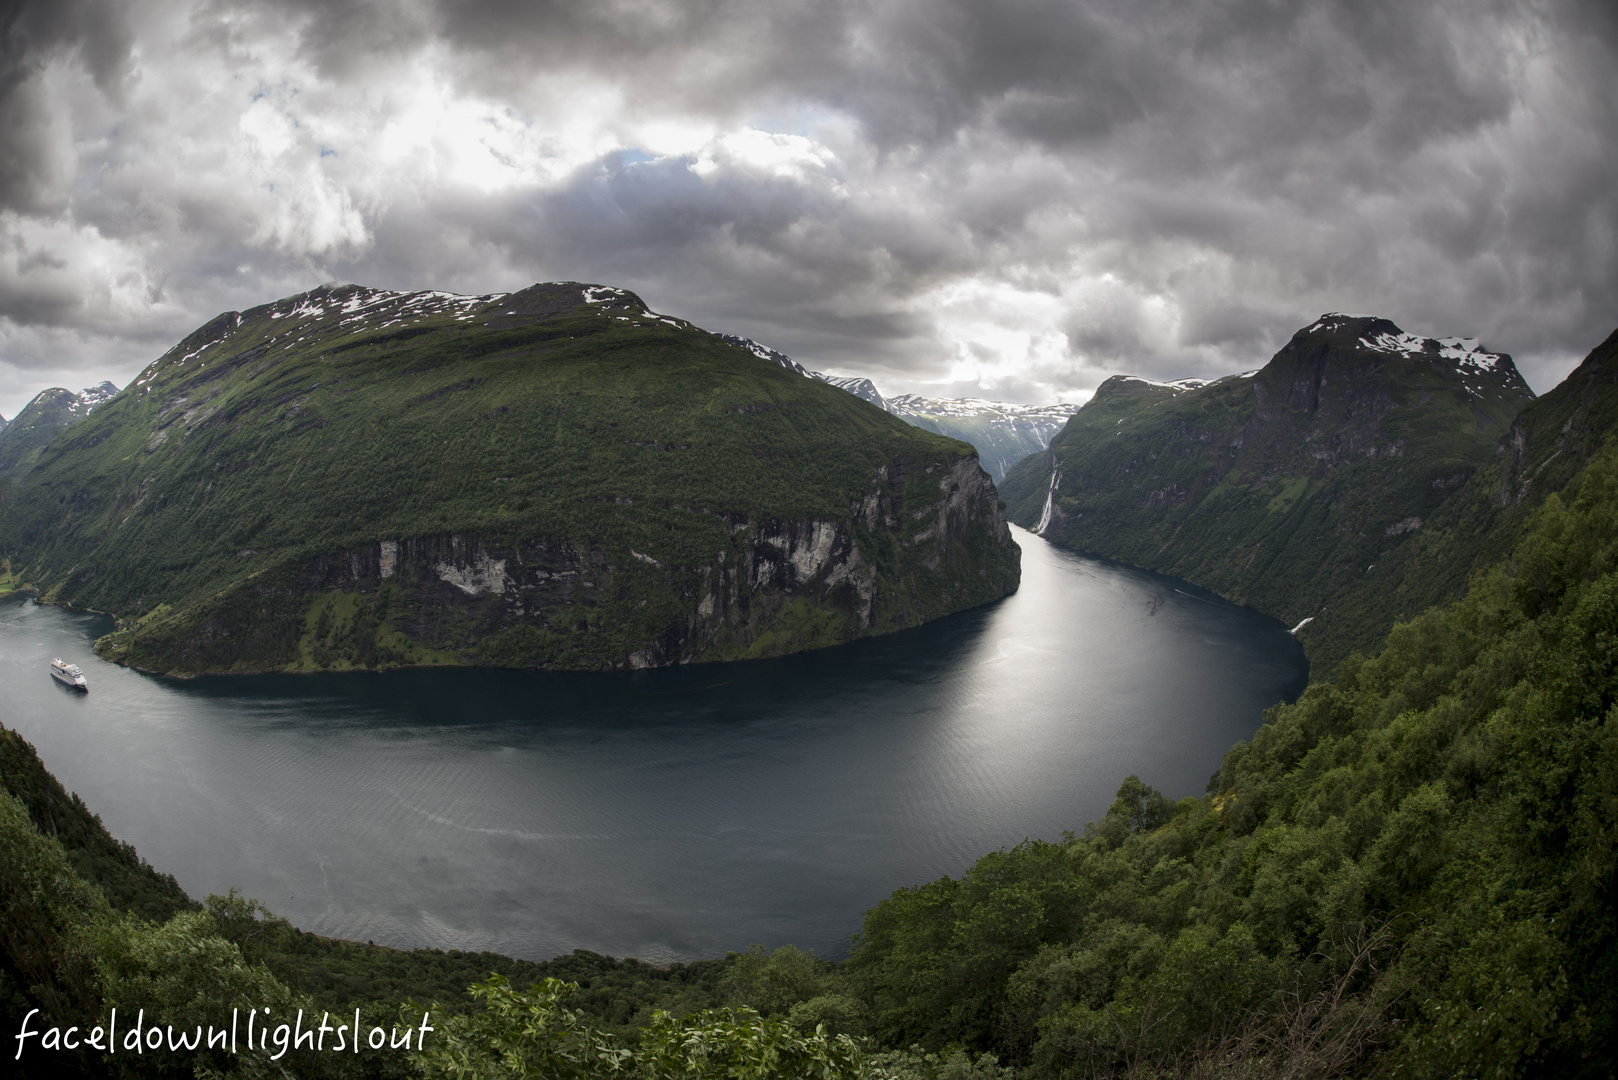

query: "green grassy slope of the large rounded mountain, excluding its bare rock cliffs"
xmin=0 ymin=285 xmax=1016 ymax=667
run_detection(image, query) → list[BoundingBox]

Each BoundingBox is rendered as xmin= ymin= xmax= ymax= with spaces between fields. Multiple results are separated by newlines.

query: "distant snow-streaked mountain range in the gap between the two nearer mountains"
xmin=725 ymin=334 xmax=1079 ymax=483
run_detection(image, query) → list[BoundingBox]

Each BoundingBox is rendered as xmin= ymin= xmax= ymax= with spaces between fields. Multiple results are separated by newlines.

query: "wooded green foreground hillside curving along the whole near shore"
xmin=0 ymin=323 xmax=1618 ymax=1080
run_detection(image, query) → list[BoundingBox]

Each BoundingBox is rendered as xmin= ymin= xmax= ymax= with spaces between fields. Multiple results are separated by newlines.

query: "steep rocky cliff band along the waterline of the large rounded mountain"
xmin=99 ymin=457 xmax=1021 ymax=672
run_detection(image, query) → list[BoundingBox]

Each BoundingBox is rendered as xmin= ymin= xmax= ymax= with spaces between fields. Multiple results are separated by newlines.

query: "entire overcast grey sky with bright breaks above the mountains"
xmin=0 ymin=0 xmax=1618 ymax=415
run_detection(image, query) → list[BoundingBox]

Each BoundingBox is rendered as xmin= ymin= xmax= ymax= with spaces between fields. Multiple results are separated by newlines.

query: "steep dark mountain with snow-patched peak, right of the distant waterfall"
xmin=1002 ymin=314 xmax=1534 ymax=674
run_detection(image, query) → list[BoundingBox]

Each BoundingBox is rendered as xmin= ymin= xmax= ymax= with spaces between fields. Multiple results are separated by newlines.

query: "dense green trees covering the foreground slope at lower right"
xmin=843 ymin=449 xmax=1618 ymax=1077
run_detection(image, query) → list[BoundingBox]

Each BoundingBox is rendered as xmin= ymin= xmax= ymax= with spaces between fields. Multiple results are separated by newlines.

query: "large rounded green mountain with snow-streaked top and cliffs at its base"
xmin=0 ymin=282 xmax=1019 ymax=674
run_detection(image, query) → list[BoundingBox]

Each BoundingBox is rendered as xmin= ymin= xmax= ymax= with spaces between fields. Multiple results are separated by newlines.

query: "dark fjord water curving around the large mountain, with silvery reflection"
xmin=0 ymin=529 xmax=1306 ymax=960
